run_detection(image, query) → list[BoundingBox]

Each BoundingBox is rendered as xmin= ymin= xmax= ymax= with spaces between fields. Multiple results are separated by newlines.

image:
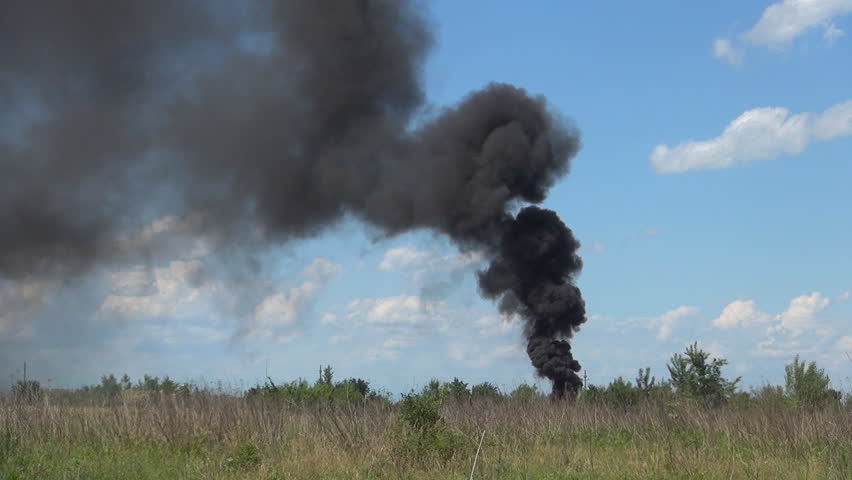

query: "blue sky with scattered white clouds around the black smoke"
xmin=0 ymin=0 xmax=852 ymax=392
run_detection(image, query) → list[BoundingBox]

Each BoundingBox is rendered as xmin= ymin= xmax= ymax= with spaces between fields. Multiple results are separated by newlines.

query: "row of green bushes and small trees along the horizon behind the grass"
xmin=11 ymin=343 xmax=852 ymax=407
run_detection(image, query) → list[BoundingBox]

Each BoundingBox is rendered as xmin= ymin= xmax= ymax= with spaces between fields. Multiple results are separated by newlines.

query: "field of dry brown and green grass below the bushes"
xmin=0 ymin=393 xmax=852 ymax=479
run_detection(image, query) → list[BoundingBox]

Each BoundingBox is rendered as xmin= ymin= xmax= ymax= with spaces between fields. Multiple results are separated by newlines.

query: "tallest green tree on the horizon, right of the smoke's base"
xmin=667 ymin=342 xmax=742 ymax=405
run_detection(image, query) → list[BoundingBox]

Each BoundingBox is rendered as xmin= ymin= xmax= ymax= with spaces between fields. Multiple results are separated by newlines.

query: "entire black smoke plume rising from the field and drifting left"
xmin=0 ymin=0 xmax=585 ymax=394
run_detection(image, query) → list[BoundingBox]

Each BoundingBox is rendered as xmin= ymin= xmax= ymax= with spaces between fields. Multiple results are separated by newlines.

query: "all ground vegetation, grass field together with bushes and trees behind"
xmin=0 ymin=345 xmax=852 ymax=480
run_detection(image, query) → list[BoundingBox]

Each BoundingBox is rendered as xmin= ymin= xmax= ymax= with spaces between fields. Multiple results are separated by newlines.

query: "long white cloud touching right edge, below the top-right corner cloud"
xmin=651 ymin=100 xmax=852 ymax=173
